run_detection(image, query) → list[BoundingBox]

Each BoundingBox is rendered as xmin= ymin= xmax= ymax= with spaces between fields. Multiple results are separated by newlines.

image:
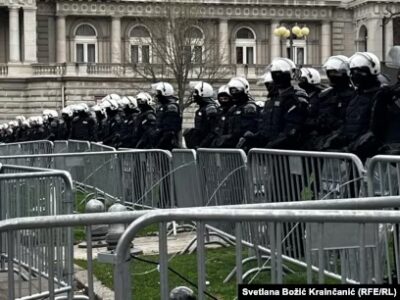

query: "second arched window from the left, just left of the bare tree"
xmin=129 ymin=25 xmax=151 ymax=64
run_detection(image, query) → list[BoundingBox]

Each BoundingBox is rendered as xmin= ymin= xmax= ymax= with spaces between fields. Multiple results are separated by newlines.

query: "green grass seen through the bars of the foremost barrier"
xmin=76 ymin=247 xmax=339 ymax=299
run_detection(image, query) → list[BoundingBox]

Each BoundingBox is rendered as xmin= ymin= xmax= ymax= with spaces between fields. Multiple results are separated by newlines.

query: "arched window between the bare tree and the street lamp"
xmin=235 ymin=27 xmax=256 ymax=65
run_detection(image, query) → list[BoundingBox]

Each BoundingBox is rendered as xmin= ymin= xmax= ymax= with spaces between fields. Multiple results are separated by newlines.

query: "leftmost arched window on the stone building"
xmin=74 ymin=24 xmax=97 ymax=63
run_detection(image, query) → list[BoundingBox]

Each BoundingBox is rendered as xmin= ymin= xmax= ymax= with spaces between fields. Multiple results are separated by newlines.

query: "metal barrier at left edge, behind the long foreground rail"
xmin=0 ymin=165 xmax=74 ymax=299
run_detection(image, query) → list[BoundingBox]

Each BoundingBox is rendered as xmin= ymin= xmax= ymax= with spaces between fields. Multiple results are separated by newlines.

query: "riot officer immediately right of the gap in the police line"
xmin=184 ymin=81 xmax=218 ymax=149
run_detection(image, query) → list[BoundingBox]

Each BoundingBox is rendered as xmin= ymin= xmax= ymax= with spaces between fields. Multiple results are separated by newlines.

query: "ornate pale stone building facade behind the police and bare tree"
xmin=0 ymin=0 xmax=400 ymax=123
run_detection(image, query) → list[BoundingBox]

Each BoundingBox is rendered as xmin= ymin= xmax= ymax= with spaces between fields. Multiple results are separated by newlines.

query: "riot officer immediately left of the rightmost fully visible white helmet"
xmin=304 ymin=55 xmax=355 ymax=151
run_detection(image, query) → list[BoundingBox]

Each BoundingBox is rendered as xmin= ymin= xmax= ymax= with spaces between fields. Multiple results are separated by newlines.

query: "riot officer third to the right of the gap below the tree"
xmin=215 ymin=77 xmax=258 ymax=148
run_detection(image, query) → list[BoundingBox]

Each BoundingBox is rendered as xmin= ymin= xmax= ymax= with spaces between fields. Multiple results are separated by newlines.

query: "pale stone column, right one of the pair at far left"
xmin=24 ymin=8 xmax=37 ymax=62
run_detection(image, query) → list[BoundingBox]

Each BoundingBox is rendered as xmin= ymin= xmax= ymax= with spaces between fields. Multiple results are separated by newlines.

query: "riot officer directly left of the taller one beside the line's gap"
xmin=136 ymin=92 xmax=157 ymax=149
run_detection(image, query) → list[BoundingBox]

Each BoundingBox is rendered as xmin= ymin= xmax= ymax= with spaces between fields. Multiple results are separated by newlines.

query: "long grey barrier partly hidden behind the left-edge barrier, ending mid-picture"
xmin=0 ymin=149 xmax=175 ymax=208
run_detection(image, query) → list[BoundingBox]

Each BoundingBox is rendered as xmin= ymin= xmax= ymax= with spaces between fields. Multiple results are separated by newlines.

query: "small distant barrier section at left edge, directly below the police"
xmin=0 ymin=140 xmax=54 ymax=155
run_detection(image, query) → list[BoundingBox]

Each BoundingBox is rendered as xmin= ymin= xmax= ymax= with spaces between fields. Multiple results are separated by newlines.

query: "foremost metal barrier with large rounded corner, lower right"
xmin=114 ymin=206 xmax=400 ymax=300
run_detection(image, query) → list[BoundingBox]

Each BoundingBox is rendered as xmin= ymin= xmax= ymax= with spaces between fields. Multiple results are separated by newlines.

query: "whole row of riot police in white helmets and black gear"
xmin=0 ymin=52 xmax=400 ymax=161
